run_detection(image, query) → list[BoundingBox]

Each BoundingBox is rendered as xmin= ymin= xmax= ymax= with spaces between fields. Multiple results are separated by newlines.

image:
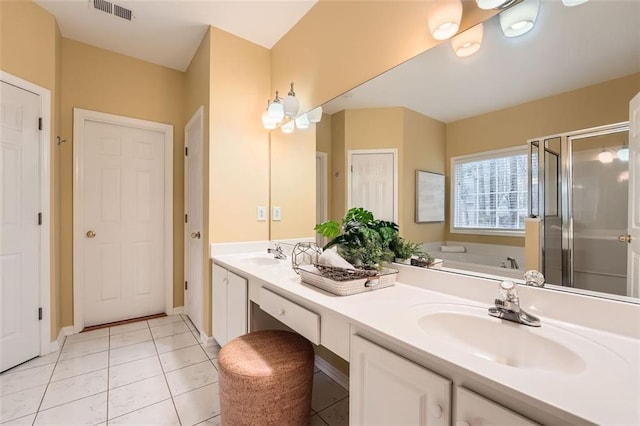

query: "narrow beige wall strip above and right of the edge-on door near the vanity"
xmin=184 ymin=29 xmax=211 ymax=335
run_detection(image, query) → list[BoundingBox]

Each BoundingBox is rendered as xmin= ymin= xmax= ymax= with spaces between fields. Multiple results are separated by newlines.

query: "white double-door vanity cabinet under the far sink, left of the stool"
xmin=212 ymin=264 xmax=247 ymax=346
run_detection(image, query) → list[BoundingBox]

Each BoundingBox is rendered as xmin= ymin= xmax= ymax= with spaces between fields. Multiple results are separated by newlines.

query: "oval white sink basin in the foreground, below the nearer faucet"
xmin=418 ymin=304 xmax=592 ymax=375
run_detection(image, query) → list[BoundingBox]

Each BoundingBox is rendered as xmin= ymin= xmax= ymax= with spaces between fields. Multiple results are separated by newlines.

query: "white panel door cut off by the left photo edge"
xmin=0 ymin=82 xmax=40 ymax=371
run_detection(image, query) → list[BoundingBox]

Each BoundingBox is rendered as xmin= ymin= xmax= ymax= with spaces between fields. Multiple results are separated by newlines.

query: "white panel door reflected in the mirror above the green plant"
xmin=349 ymin=153 xmax=397 ymax=222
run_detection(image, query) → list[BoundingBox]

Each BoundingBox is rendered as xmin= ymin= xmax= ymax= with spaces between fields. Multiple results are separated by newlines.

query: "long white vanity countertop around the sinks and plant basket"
xmin=213 ymin=252 xmax=640 ymax=425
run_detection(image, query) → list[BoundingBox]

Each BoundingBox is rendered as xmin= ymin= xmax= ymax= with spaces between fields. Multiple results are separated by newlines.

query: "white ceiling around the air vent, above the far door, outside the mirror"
xmin=35 ymin=0 xmax=317 ymax=71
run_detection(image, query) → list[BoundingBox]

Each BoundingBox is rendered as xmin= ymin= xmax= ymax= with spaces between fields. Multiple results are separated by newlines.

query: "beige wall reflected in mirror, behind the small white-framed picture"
xmin=400 ymin=108 xmax=446 ymax=243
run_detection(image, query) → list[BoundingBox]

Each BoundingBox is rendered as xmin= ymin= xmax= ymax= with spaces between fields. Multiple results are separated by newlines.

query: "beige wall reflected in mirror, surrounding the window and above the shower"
xmin=446 ymin=73 xmax=640 ymax=246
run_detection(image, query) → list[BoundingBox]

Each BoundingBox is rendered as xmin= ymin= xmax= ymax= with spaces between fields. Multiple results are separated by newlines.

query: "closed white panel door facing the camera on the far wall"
xmin=78 ymin=120 xmax=165 ymax=326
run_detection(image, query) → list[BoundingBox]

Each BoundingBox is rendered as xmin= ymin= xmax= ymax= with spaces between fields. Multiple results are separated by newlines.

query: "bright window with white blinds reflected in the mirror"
xmin=452 ymin=148 xmax=529 ymax=233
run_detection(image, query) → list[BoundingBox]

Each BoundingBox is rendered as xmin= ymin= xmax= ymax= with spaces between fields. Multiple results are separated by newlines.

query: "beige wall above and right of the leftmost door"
xmin=0 ymin=1 xmax=64 ymax=340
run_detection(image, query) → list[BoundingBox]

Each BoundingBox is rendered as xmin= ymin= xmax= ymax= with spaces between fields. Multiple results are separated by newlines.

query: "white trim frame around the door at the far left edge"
xmin=0 ymin=70 xmax=53 ymax=355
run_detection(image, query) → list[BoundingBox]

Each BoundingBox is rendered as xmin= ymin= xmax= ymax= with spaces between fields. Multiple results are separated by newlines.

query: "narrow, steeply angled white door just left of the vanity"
xmin=184 ymin=108 xmax=204 ymax=332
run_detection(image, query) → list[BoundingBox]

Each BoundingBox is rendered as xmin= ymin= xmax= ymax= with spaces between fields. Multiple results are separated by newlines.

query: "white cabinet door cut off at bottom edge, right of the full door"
xmin=456 ymin=388 xmax=538 ymax=426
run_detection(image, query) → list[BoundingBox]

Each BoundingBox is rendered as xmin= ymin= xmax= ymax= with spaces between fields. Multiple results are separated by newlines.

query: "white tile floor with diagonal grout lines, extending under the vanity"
xmin=0 ymin=315 xmax=349 ymax=426
